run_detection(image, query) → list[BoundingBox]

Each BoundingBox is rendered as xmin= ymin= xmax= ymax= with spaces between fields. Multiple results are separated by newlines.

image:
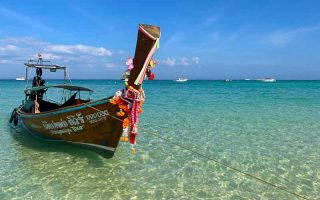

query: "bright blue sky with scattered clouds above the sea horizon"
xmin=0 ymin=0 xmax=320 ymax=79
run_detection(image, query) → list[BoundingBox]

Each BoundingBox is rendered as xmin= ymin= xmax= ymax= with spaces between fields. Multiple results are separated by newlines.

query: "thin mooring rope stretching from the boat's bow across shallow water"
xmin=83 ymin=104 xmax=308 ymax=199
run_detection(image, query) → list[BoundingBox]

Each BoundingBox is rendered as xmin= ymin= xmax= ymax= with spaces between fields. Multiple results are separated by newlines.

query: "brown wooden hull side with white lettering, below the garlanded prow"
xmin=18 ymin=99 xmax=127 ymax=157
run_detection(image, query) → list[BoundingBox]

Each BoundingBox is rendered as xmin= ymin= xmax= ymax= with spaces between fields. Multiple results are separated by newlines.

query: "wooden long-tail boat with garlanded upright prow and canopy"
xmin=9 ymin=24 xmax=160 ymax=157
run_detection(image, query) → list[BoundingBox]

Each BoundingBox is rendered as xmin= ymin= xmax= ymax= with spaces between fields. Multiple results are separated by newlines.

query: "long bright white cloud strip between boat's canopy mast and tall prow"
xmin=46 ymin=44 xmax=112 ymax=56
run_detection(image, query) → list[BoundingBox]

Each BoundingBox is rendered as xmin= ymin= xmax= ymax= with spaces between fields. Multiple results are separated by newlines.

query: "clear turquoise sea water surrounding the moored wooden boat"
xmin=0 ymin=80 xmax=320 ymax=200
